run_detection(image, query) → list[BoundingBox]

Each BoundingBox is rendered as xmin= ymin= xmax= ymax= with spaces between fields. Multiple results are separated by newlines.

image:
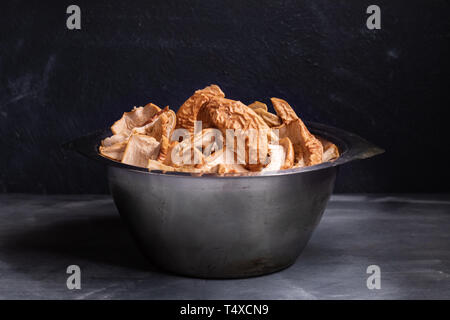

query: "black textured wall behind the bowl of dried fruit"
xmin=0 ymin=0 xmax=450 ymax=193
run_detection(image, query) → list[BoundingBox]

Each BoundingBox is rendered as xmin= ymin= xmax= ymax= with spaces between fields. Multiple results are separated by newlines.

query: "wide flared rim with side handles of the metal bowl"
xmin=63 ymin=121 xmax=384 ymax=179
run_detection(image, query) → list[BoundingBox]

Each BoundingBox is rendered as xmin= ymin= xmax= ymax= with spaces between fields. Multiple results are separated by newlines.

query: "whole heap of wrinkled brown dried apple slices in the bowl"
xmin=99 ymin=85 xmax=339 ymax=175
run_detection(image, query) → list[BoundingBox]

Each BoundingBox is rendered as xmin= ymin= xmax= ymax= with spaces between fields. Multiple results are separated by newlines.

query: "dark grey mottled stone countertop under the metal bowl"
xmin=0 ymin=194 xmax=450 ymax=299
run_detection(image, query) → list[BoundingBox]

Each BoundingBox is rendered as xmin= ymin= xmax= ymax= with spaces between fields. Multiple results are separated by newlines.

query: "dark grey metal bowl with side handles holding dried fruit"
xmin=68 ymin=123 xmax=383 ymax=278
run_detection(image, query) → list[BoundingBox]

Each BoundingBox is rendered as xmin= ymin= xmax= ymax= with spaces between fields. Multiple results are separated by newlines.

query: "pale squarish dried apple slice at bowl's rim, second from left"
xmin=122 ymin=134 xmax=160 ymax=168
